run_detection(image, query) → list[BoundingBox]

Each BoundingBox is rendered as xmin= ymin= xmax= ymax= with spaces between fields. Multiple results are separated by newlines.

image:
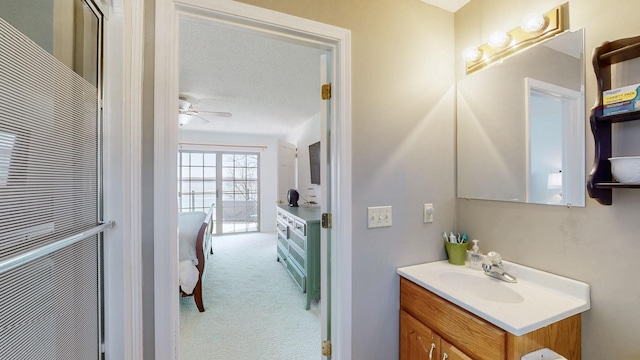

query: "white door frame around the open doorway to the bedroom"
xmin=154 ymin=0 xmax=352 ymax=360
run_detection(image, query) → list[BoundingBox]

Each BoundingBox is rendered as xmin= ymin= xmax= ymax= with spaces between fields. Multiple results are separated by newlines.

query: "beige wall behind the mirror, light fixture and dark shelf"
xmin=455 ymin=0 xmax=640 ymax=360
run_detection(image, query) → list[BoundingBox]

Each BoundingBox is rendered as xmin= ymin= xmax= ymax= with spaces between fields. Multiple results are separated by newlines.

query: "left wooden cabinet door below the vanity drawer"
xmin=400 ymin=310 xmax=440 ymax=360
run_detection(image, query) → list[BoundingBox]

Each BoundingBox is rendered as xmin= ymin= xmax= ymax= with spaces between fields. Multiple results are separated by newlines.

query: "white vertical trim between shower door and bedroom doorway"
xmin=101 ymin=0 xmax=144 ymax=360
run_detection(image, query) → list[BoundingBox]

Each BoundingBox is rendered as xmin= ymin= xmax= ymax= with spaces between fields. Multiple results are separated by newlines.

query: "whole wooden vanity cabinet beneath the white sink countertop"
xmin=400 ymin=277 xmax=581 ymax=360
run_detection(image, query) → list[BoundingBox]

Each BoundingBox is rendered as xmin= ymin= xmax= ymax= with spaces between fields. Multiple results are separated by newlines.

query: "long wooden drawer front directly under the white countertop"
xmin=400 ymin=277 xmax=507 ymax=360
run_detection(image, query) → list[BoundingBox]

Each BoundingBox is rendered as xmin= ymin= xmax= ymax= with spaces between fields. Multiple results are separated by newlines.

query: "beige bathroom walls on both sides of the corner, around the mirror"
xmin=211 ymin=0 xmax=640 ymax=360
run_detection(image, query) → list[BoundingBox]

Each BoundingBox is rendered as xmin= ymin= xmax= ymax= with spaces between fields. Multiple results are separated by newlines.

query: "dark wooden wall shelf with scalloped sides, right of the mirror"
xmin=587 ymin=36 xmax=640 ymax=205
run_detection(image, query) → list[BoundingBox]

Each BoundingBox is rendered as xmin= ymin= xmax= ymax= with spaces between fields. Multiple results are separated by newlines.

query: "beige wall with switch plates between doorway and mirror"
xmin=238 ymin=0 xmax=455 ymax=360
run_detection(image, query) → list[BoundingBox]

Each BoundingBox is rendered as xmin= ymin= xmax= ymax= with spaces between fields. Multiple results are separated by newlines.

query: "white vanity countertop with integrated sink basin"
xmin=397 ymin=260 xmax=591 ymax=336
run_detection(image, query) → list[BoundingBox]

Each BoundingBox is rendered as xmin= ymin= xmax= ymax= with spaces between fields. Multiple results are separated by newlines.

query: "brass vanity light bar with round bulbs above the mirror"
xmin=463 ymin=5 xmax=567 ymax=74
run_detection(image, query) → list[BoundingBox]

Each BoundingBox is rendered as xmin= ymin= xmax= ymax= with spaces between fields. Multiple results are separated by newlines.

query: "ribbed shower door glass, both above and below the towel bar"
xmin=0 ymin=11 xmax=101 ymax=359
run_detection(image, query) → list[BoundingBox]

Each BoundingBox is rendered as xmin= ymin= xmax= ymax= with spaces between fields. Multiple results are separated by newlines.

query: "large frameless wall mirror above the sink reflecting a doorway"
xmin=457 ymin=30 xmax=586 ymax=206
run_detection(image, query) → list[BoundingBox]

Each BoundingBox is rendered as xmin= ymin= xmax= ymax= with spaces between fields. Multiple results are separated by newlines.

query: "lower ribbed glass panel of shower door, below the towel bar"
xmin=0 ymin=237 xmax=98 ymax=360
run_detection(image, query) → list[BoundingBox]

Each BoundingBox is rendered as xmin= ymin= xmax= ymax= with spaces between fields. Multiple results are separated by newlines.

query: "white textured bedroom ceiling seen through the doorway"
xmin=176 ymin=18 xmax=326 ymax=136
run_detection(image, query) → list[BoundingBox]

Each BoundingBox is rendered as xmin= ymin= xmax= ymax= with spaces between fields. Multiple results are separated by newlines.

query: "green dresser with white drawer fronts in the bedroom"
xmin=276 ymin=205 xmax=321 ymax=310
